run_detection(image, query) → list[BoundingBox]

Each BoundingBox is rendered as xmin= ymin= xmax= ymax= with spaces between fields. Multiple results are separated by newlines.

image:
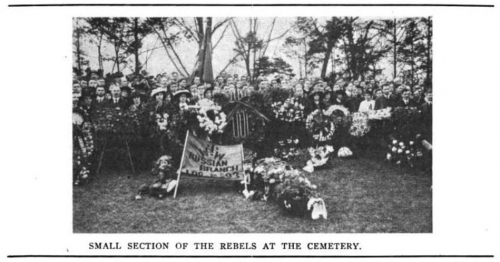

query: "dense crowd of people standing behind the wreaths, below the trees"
xmin=73 ymin=67 xmax=432 ymax=185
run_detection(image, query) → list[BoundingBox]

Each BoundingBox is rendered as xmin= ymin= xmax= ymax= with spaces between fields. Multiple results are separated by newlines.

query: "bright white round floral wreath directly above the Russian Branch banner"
xmin=197 ymin=99 xmax=227 ymax=134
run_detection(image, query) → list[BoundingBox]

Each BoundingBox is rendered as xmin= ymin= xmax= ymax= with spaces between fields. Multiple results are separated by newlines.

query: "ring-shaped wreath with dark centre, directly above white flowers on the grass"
xmin=306 ymin=109 xmax=335 ymax=142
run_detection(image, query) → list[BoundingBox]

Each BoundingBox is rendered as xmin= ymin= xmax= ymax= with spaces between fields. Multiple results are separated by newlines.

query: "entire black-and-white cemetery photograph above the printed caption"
xmin=72 ymin=17 xmax=433 ymax=233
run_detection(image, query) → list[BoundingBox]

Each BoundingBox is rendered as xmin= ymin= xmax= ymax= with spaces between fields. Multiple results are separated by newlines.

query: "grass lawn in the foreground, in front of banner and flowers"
xmin=73 ymin=154 xmax=432 ymax=233
